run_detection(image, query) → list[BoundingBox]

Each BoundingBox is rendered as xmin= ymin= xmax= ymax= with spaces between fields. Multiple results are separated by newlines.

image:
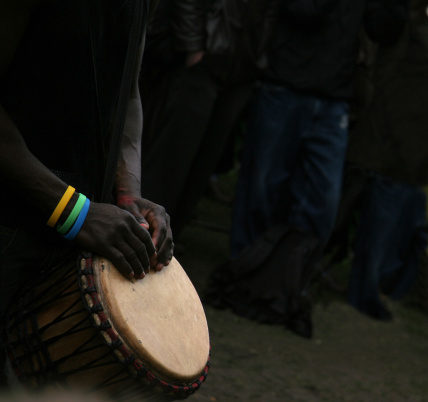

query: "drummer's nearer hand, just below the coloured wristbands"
xmin=76 ymin=202 xmax=157 ymax=279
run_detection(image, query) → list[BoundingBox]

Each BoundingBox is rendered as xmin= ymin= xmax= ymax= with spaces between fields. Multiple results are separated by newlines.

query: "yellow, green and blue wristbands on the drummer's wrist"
xmin=47 ymin=186 xmax=90 ymax=240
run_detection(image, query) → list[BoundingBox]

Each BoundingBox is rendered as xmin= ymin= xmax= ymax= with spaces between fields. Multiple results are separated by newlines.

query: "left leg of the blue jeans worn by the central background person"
xmin=231 ymin=85 xmax=303 ymax=256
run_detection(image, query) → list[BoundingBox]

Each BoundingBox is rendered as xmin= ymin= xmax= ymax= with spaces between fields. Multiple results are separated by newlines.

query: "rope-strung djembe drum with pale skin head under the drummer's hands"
xmin=6 ymin=253 xmax=210 ymax=401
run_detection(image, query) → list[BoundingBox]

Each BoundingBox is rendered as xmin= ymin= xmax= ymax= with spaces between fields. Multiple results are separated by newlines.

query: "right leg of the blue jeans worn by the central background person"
xmin=288 ymin=98 xmax=348 ymax=243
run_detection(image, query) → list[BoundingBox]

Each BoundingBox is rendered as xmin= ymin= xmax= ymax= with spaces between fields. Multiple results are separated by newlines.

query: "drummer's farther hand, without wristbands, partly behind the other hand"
xmin=117 ymin=195 xmax=174 ymax=271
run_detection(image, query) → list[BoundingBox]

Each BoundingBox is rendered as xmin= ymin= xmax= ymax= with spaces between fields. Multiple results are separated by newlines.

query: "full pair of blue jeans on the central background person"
xmin=231 ymin=84 xmax=348 ymax=256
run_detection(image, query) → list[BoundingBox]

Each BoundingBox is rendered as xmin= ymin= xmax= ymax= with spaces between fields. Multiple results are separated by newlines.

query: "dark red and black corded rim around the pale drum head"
xmin=77 ymin=251 xmax=211 ymax=397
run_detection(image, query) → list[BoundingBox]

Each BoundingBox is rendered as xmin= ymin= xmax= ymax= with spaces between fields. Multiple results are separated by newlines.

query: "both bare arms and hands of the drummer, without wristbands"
xmin=0 ymin=0 xmax=173 ymax=278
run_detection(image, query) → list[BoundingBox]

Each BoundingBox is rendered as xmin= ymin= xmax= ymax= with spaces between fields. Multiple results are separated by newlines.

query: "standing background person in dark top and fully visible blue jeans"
xmin=209 ymin=0 xmax=407 ymax=338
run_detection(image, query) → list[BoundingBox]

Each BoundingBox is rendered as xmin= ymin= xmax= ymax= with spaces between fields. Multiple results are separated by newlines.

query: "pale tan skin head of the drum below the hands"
xmin=93 ymin=257 xmax=209 ymax=382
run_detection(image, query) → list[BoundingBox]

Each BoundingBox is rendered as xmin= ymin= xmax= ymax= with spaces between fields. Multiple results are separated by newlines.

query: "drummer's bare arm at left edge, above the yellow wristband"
xmin=0 ymin=0 xmax=72 ymax=218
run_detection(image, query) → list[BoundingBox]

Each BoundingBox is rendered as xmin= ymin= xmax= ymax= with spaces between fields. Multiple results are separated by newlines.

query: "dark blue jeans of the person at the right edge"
xmin=348 ymin=175 xmax=427 ymax=319
